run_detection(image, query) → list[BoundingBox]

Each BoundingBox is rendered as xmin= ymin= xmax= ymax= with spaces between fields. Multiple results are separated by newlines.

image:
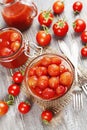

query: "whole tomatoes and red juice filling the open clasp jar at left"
xmin=0 ymin=30 xmax=28 ymax=68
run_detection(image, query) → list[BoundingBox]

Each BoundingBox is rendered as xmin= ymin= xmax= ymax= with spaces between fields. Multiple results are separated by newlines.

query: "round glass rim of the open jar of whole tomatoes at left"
xmin=0 ymin=27 xmax=23 ymax=61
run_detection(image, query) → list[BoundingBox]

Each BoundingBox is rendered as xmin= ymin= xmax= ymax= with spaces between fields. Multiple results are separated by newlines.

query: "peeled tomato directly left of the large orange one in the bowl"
xmin=49 ymin=77 xmax=59 ymax=89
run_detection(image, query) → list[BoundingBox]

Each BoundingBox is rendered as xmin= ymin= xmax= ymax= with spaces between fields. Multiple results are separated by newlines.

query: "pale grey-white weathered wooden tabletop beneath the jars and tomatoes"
xmin=0 ymin=0 xmax=87 ymax=130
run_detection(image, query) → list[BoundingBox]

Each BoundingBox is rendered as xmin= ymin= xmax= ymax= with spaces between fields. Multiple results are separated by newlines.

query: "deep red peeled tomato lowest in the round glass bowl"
xmin=42 ymin=88 xmax=55 ymax=99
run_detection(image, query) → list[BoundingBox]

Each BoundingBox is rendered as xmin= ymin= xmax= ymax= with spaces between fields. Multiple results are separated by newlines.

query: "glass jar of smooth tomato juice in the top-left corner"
xmin=0 ymin=0 xmax=37 ymax=31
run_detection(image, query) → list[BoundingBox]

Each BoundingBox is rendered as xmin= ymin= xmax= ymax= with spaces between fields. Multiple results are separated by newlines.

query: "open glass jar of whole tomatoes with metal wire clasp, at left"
xmin=0 ymin=27 xmax=42 ymax=68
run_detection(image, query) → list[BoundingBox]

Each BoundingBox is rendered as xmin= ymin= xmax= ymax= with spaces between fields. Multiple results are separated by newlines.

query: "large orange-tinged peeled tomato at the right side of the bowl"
xmin=59 ymin=72 xmax=73 ymax=86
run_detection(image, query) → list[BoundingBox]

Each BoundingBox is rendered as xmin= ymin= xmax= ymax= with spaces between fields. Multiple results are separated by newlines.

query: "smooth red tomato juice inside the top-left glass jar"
xmin=2 ymin=2 xmax=33 ymax=31
